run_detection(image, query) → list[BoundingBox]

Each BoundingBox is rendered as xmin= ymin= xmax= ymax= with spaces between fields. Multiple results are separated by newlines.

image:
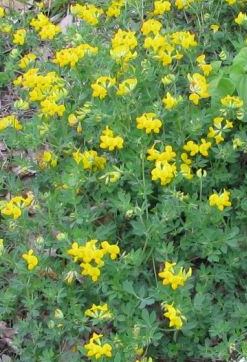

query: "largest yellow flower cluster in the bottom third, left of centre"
xmin=68 ymin=239 xmax=120 ymax=282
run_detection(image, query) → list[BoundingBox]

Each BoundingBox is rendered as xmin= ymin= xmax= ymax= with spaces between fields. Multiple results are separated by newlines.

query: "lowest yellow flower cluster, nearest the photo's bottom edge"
xmin=84 ymin=333 xmax=112 ymax=359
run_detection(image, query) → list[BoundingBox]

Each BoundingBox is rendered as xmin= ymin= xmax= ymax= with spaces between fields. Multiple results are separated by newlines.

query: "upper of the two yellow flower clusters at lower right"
xmin=159 ymin=261 xmax=192 ymax=289
